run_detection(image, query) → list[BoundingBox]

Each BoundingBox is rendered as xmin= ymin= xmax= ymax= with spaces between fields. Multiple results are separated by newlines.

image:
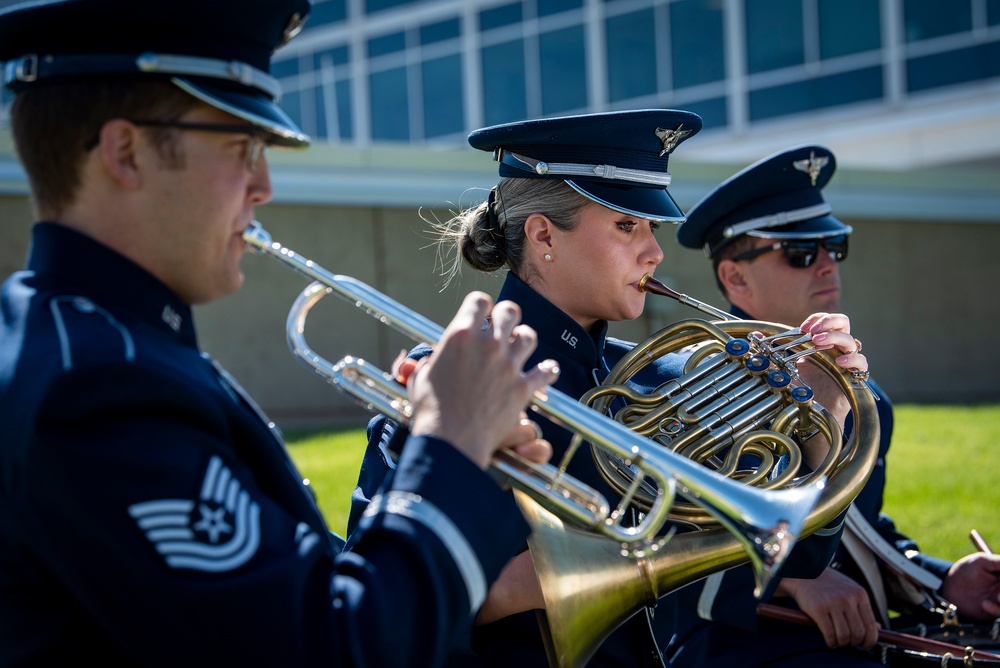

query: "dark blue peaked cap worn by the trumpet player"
xmin=0 ymin=0 xmax=310 ymax=147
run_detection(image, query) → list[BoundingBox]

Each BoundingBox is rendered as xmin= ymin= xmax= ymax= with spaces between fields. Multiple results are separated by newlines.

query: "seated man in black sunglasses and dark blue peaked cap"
xmin=672 ymin=146 xmax=1000 ymax=668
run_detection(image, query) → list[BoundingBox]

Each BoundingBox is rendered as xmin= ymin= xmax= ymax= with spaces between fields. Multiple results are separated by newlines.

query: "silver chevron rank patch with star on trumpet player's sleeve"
xmin=128 ymin=457 xmax=260 ymax=573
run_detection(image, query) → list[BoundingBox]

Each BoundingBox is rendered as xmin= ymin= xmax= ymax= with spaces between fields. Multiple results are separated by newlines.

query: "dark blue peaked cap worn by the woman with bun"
xmin=469 ymin=109 xmax=701 ymax=222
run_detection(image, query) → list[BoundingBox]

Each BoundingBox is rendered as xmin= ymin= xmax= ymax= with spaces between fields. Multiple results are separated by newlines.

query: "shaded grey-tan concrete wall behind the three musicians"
xmin=0 ymin=165 xmax=1000 ymax=429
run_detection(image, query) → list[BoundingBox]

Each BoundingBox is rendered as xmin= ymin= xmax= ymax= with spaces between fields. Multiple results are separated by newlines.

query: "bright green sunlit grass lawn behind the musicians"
xmin=288 ymin=405 xmax=1000 ymax=559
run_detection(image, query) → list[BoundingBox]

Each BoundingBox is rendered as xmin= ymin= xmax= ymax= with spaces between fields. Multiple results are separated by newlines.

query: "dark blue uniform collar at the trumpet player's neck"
xmin=28 ymin=222 xmax=197 ymax=347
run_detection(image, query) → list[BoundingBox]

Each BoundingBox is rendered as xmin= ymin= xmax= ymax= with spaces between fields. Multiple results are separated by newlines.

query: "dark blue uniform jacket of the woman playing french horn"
xmin=348 ymin=273 xmax=840 ymax=666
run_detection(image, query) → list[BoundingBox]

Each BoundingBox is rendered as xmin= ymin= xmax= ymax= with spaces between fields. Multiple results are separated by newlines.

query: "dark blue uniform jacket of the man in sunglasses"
xmin=672 ymin=307 xmax=950 ymax=668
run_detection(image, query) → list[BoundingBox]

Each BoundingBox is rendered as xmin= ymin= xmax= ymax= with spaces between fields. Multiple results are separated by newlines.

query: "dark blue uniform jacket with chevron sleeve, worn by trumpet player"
xmin=0 ymin=223 xmax=527 ymax=666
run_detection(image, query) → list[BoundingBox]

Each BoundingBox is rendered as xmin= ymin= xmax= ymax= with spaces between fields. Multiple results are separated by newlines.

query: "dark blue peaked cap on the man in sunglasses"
xmin=677 ymin=146 xmax=852 ymax=257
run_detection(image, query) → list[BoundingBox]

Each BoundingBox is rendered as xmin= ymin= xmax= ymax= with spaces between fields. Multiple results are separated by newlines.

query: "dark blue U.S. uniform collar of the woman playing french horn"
xmin=497 ymin=272 xmax=608 ymax=369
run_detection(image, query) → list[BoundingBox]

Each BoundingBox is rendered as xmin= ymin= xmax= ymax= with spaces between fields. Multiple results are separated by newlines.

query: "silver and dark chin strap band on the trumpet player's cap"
xmin=3 ymin=53 xmax=281 ymax=100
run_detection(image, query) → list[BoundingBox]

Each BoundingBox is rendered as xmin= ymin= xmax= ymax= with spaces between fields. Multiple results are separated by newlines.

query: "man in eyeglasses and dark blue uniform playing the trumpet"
xmin=0 ymin=0 xmax=558 ymax=666
